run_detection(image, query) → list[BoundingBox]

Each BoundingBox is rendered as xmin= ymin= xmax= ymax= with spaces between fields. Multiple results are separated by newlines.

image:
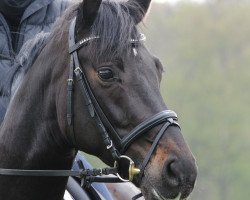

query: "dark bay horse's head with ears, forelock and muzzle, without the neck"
xmin=58 ymin=0 xmax=197 ymax=199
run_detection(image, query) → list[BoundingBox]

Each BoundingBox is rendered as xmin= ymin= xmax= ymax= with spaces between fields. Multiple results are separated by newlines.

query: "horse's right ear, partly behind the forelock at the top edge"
xmin=127 ymin=0 xmax=151 ymax=24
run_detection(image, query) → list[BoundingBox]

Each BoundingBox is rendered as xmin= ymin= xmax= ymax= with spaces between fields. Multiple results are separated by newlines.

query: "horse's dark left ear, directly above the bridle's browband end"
xmin=76 ymin=0 xmax=102 ymax=29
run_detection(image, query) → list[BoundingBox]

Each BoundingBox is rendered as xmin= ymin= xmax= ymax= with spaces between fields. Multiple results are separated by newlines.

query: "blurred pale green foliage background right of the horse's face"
xmin=144 ymin=0 xmax=250 ymax=200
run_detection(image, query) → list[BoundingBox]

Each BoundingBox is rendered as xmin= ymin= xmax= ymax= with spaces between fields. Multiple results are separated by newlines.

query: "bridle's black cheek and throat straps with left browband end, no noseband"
xmin=67 ymin=18 xmax=119 ymax=160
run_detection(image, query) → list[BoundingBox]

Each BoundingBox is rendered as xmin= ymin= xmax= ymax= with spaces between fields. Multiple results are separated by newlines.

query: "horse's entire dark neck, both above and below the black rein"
xmin=0 ymin=33 xmax=75 ymax=200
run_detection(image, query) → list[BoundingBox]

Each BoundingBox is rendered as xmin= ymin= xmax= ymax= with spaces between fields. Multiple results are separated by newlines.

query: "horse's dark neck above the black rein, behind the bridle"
xmin=0 ymin=32 xmax=74 ymax=172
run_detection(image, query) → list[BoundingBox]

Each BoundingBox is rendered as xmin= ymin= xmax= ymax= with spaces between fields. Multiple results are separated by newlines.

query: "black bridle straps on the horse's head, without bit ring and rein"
xmin=67 ymin=18 xmax=179 ymax=181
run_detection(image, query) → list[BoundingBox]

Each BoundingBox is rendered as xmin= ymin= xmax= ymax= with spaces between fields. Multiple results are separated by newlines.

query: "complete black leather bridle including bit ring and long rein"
xmin=0 ymin=18 xmax=180 ymax=192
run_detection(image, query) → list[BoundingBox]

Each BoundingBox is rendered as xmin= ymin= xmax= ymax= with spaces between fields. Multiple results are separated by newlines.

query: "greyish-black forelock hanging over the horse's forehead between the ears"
xmin=86 ymin=0 xmax=139 ymax=60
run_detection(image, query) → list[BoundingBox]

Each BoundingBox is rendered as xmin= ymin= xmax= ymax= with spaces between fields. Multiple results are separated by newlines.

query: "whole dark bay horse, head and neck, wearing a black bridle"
xmin=0 ymin=0 xmax=197 ymax=200
